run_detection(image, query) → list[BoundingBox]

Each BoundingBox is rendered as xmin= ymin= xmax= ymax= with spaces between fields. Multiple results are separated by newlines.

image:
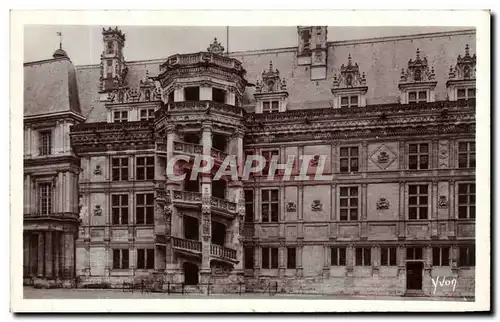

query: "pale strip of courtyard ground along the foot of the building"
xmin=23 ymin=287 xmax=474 ymax=302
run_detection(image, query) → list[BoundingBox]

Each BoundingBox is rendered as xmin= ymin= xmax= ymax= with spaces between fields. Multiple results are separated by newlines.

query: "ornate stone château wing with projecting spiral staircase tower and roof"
xmin=25 ymin=27 xmax=475 ymax=296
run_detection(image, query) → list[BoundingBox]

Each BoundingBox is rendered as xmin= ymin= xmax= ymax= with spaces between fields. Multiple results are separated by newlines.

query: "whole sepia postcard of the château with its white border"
xmin=10 ymin=11 xmax=491 ymax=312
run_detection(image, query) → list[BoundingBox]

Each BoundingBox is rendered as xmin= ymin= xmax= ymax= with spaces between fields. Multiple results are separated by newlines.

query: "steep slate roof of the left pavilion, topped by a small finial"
xmin=24 ymin=58 xmax=82 ymax=116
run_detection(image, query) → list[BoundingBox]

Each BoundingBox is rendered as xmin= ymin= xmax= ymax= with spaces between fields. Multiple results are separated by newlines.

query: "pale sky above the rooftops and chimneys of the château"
xmin=24 ymin=25 xmax=467 ymax=65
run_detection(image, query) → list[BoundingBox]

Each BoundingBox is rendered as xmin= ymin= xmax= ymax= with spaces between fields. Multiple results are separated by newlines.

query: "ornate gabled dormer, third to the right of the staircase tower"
xmin=399 ymin=48 xmax=437 ymax=104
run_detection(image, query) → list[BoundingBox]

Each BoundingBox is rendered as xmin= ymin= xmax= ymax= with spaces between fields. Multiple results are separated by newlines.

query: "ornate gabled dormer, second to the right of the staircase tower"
xmin=332 ymin=54 xmax=368 ymax=108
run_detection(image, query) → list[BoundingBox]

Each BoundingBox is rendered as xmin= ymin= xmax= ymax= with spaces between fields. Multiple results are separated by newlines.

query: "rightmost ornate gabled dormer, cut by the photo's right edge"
xmin=446 ymin=45 xmax=476 ymax=101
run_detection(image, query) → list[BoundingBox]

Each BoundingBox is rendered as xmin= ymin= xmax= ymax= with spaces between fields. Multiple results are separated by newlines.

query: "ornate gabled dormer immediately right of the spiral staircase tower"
xmin=254 ymin=62 xmax=288 ymax=113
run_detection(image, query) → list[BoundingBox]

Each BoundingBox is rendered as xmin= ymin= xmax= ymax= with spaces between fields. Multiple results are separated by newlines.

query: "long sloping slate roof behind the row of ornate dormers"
xmin=71 ymin=30 xmax=476 ymax=122
